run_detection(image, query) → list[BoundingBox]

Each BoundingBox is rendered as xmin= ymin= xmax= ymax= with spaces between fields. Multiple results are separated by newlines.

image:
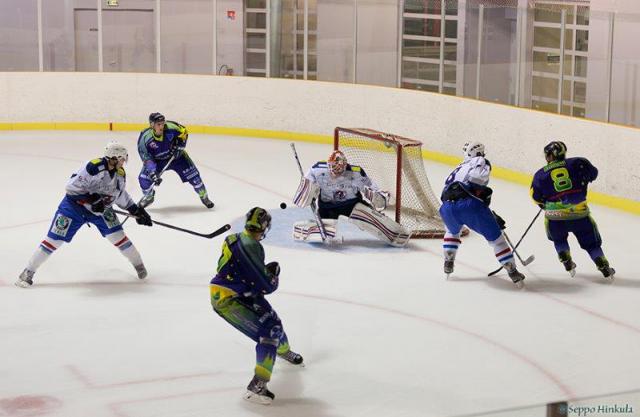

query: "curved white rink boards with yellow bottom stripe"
xmin=0 ymin=72 xmax=640 ymax=214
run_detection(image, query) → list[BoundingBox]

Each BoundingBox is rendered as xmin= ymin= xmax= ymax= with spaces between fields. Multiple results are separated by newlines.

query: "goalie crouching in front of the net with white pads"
xmin=293 ymin=150 xmax=410 ymax=247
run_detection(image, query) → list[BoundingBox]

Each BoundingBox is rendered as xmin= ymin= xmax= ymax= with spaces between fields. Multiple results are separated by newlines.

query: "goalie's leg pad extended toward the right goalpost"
xmin=349 ymin=203 xmax=411 ymax=247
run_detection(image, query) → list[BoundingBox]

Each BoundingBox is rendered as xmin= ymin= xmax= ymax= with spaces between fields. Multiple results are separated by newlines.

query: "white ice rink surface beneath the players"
xmin=0 ymin=131 xmax=640 ymax=417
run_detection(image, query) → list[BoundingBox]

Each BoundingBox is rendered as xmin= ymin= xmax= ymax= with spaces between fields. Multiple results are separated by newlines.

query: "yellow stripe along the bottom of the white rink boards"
xmin=0 ymin=122 xmax=640 ymax=215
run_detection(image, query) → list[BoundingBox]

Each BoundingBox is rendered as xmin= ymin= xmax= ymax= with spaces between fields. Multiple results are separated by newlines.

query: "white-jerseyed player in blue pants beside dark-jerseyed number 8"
xmin=440 ymin=142 xmax=525 ymax=287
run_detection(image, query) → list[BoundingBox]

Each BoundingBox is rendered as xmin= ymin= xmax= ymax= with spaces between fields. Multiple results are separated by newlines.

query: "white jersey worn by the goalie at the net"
xmin=305 ymin=161 xmax=378 ymax=203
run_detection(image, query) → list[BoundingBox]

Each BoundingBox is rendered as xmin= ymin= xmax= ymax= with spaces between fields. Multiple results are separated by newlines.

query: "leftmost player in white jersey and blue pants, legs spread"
xmin=16 ymin=142 xmax=152 ymax=288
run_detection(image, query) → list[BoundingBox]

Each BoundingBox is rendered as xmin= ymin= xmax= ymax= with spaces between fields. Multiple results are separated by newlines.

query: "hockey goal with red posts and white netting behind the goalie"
xmin=333 ymin=127 xmax=444 ymax=239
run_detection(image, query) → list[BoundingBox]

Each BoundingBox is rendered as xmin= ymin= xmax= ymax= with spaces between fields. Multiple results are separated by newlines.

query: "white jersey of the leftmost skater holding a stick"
xmin=65 ymin=158 xmax=134 ymax=209
